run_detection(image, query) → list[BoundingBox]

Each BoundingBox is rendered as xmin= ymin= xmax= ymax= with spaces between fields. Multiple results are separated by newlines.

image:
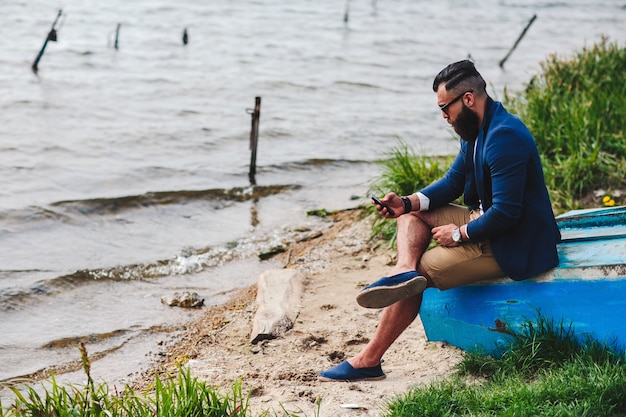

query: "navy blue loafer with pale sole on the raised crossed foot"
xmin=356 ymin=271 xmax=427 ymax=308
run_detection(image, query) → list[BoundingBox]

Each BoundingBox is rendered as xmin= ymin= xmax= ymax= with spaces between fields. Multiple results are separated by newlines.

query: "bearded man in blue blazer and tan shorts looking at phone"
xmin=320 ymin=60 xmax=561 ymax=381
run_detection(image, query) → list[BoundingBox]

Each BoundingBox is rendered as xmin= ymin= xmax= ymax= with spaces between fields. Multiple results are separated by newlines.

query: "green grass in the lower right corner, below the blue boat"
xmin=387 ymin=316 xmax=626 ymax=417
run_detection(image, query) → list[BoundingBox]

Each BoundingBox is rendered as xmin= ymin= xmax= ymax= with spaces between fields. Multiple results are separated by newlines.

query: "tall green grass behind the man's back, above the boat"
xmin=505 ymin=39 xmax=626 ymax=211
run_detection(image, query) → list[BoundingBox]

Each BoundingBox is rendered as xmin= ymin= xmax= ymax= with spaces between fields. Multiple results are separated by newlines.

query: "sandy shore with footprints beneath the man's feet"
xmin=137 ymin=210 xmax=461 ymax=417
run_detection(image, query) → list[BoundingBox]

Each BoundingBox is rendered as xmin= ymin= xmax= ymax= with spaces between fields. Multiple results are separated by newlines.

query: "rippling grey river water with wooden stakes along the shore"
xmin=0 ymin=0 xmax=626 ymax=394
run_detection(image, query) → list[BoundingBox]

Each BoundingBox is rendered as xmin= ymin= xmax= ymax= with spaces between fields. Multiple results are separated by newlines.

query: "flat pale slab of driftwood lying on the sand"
xmin=250 ymin=269 xmax=304 ymax=344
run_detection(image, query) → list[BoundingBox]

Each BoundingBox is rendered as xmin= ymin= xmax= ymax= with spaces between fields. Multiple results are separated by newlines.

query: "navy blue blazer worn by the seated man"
xmin=422 ymin=98 xmax=561 ymax=280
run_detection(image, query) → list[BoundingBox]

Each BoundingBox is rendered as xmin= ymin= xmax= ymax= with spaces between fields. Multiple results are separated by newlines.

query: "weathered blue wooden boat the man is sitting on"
xmin=420 ymin=206 xmax=626 ymax=356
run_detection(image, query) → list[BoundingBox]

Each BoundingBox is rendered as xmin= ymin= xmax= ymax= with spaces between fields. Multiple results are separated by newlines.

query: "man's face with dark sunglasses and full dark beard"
xmin=437 ymin=84 xmax=480 ymax=142
